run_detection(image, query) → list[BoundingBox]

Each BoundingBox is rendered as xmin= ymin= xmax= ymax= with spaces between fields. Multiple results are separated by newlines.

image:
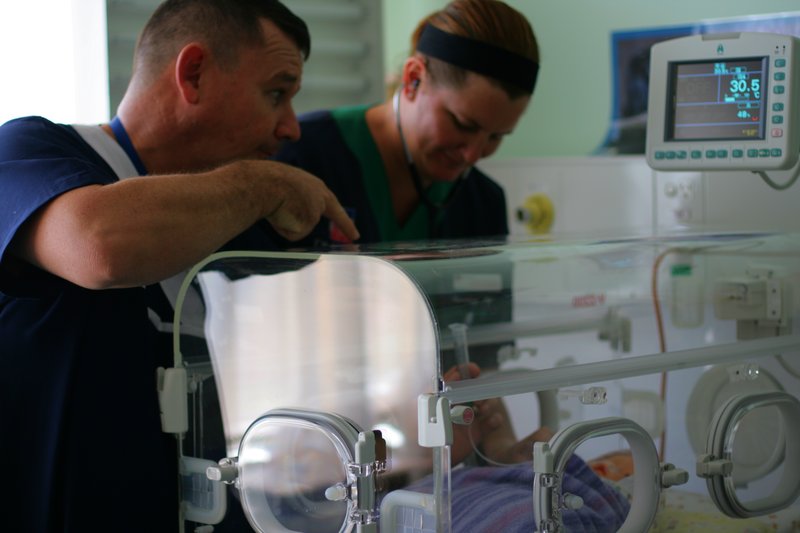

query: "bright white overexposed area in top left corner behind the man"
xmin=0 ymin=0 xmax=109 ymax=123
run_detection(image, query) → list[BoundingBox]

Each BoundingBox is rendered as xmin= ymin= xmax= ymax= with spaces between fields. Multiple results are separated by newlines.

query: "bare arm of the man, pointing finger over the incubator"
xmin=11 ymin=161 xmax=358 ymax=289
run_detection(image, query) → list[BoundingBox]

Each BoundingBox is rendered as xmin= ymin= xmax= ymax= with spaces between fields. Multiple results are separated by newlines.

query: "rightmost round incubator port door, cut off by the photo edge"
xmin=697 ymin=391 xmax=800 ymax=518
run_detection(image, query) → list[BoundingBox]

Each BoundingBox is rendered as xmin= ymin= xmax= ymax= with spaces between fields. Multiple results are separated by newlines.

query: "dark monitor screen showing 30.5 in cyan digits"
xmin=665 ymin=57 xmax=769 ymax=141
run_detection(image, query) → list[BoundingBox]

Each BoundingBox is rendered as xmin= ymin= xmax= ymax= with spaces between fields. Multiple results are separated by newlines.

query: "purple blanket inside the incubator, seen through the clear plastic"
xmin=408 ymin=455 xmax=630 ymax=533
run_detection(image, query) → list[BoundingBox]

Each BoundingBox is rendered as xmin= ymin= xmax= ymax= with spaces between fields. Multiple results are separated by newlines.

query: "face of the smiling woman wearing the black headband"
xmin=403 ymin=72 xmax=530 ymax=181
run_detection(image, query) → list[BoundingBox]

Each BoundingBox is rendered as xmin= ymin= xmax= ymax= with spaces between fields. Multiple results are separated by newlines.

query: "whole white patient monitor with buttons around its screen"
xmin=647 ymin=33 xmax=800 ymax=171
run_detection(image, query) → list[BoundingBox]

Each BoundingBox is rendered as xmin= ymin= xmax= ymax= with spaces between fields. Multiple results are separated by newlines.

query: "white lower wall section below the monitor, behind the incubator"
xmin=479 ymin=156 xmax=800 ymax=237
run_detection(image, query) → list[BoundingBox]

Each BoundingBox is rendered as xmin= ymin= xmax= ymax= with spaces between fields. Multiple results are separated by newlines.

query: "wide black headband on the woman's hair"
xmin=417 ymin=24 xmax=539 ymax=94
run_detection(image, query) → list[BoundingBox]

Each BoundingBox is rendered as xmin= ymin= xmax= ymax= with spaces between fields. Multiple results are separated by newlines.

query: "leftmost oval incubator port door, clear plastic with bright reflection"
xmin=214 ymin=409 xmax=386 ymax=533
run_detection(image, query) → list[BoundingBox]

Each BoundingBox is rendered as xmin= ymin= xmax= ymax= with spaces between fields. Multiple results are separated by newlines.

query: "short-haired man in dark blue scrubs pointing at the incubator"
xmin=0 ymin=0 xmax=358 ymax=531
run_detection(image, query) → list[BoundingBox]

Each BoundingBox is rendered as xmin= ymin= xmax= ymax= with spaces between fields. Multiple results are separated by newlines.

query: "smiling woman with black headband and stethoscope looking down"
xmin=278 ymin=0 xmax=539 ymax=245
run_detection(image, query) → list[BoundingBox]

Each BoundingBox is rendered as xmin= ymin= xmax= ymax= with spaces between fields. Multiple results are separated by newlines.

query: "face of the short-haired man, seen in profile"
xmin=192 ymin=20 xmax=303 ymax=167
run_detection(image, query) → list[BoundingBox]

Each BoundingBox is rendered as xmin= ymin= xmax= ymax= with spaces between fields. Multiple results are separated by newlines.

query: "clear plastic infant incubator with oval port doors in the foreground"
xmin=161 ymin=233 xmax=800 ymax=533
